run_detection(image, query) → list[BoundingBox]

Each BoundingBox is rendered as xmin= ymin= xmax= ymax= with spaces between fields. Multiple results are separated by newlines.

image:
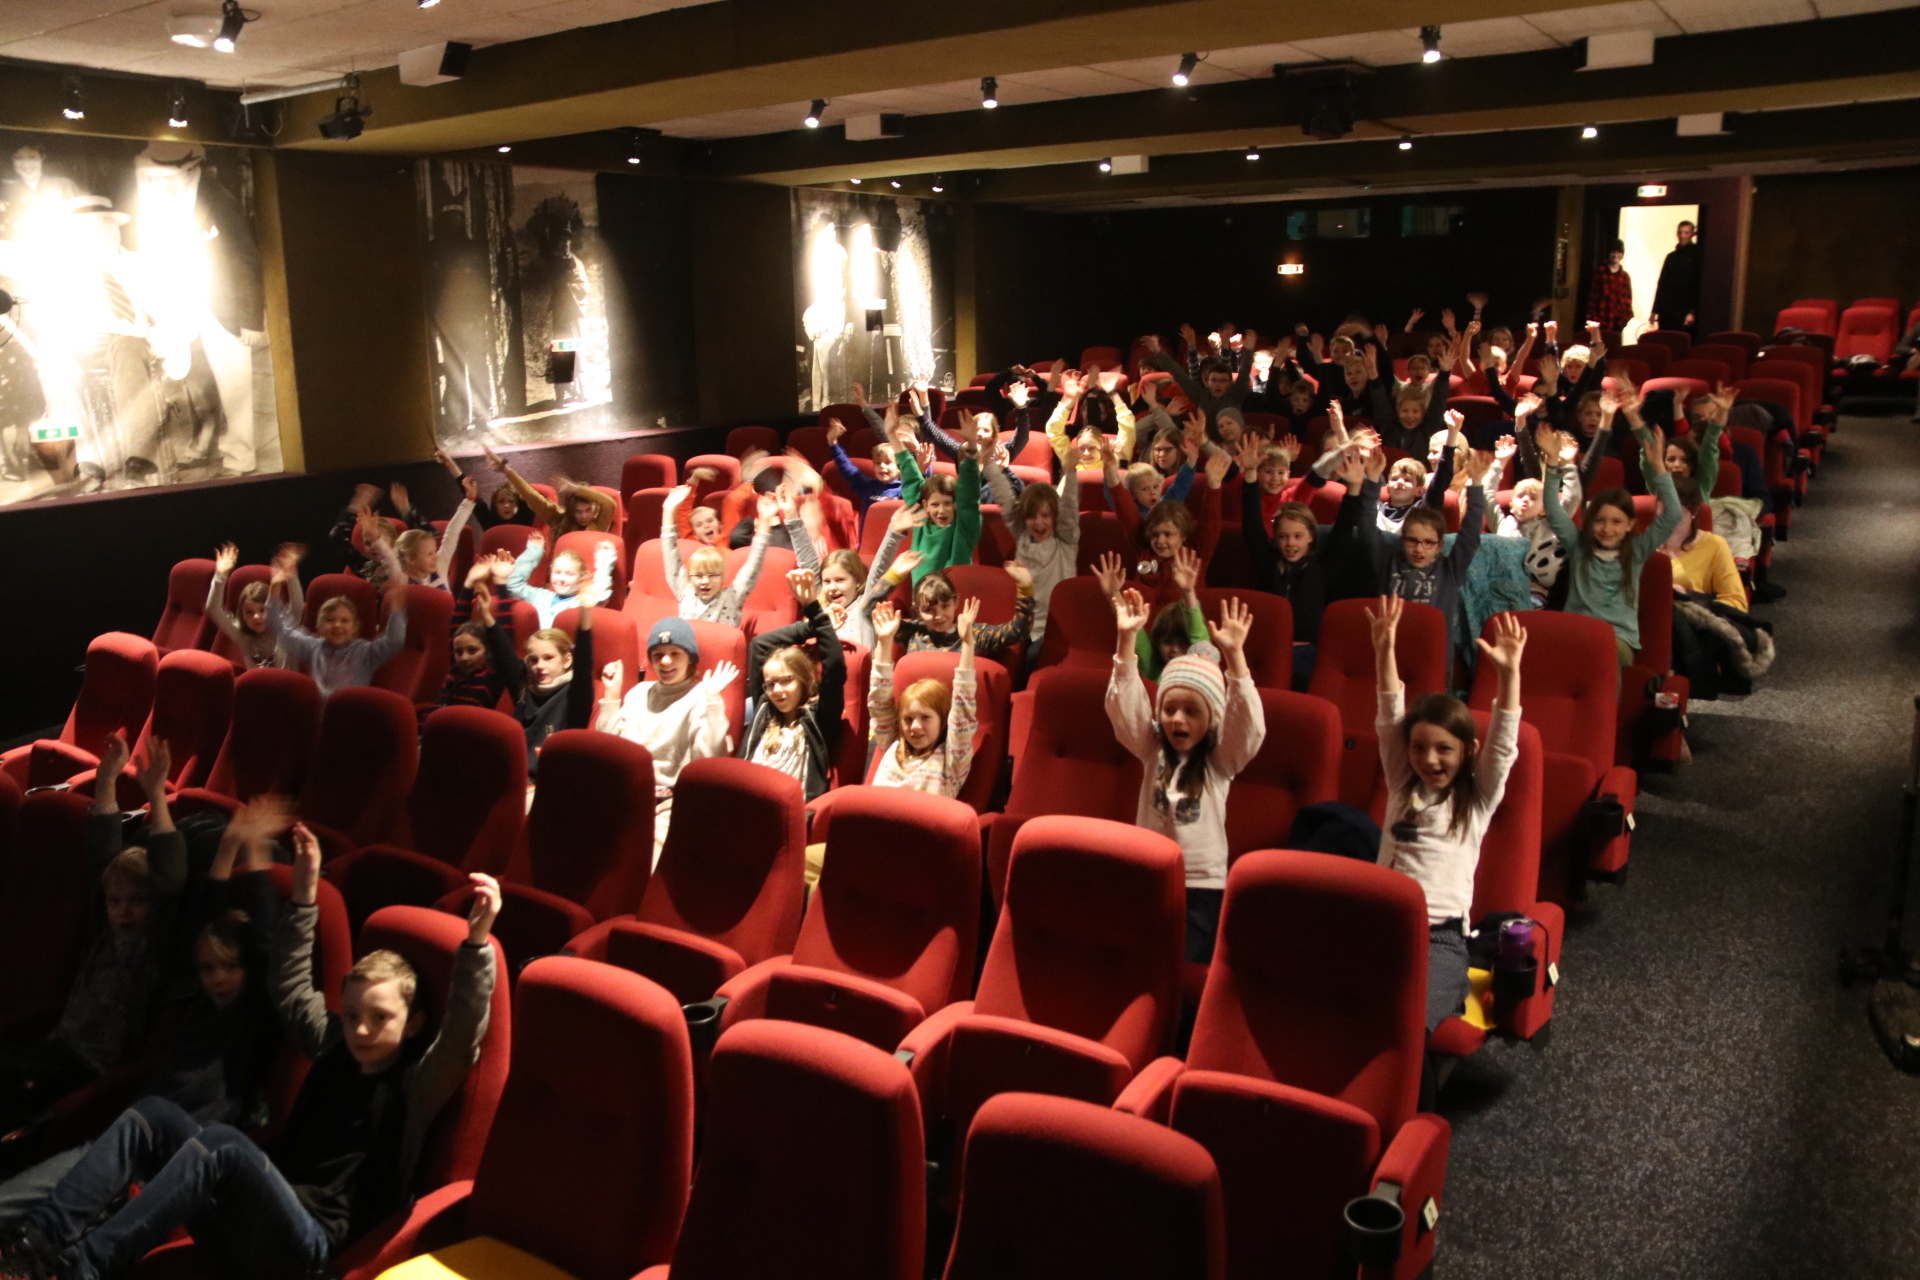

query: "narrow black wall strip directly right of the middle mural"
xmin=595 ymin=173 xmax=699 ymax=430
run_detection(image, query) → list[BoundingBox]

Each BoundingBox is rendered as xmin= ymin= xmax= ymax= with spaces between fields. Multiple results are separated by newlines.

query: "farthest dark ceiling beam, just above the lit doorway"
xmin=948 ymin=100 xmax=1920 ymax=205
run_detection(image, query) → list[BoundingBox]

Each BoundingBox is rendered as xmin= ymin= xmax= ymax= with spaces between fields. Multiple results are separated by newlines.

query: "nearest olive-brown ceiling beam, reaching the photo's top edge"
xmin=263 ymin=0 xmax=1628 ymax=152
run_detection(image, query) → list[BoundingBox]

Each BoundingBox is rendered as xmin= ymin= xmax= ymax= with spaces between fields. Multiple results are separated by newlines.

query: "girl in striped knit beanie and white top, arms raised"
xmin=1106 ymin=587 xmax=1267 ymax=963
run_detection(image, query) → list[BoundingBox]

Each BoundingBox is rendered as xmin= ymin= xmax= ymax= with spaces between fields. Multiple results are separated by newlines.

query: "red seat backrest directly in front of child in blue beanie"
xmin=637 ymin=756 xmax=806 ymax=965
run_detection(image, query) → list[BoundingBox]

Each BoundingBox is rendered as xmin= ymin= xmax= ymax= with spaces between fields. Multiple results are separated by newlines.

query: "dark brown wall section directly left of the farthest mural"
xmin=687 ymin=182 xmax=799 ymax=424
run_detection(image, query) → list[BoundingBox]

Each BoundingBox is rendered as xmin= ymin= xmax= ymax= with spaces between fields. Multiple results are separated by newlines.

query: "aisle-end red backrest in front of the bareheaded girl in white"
xmin=1187 ymin=848 xmax=1427 ymax=1148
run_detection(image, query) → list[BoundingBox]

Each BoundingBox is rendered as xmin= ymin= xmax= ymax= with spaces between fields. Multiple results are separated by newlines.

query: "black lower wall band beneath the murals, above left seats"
xmin=0 ymin=430 xmax=724 ymax=741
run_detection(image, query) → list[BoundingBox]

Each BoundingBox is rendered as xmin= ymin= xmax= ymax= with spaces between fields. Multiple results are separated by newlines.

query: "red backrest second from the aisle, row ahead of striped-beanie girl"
xmin=973 ymin=816 xmax=1187 ymax=1071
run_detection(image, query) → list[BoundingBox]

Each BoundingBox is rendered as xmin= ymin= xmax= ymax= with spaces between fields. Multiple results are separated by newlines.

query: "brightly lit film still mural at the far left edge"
xmin=0 ymin=129 xmax=280 ymax=503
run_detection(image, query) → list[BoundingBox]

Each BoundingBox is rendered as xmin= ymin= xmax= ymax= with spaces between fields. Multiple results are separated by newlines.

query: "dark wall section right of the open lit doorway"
xmin=1745 ymin=169 xmax=1920 ymax=330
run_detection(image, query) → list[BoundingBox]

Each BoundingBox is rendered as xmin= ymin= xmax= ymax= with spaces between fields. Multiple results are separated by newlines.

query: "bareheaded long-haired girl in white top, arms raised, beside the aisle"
xmin=1367 ymin=595 xmax=1526 ymax=1032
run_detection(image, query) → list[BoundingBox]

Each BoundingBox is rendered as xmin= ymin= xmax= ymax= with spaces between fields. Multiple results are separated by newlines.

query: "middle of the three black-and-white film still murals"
xmin=417 ymin=159 xmax=616 ymax=449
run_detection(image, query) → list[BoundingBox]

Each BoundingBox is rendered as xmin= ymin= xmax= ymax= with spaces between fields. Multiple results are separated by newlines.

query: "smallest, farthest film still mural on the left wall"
xmin=793 ymin=188 xmax=954 ymax=413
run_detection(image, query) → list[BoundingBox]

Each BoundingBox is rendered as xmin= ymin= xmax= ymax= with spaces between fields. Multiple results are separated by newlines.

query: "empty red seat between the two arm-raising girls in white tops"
xmin=1227 ymin=687 xmax=1340 ymax=858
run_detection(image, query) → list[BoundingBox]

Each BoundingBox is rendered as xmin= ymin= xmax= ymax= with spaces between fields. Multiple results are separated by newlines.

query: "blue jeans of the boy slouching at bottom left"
xmin=27 ymin=1098 xmax=330 ymax=1280
